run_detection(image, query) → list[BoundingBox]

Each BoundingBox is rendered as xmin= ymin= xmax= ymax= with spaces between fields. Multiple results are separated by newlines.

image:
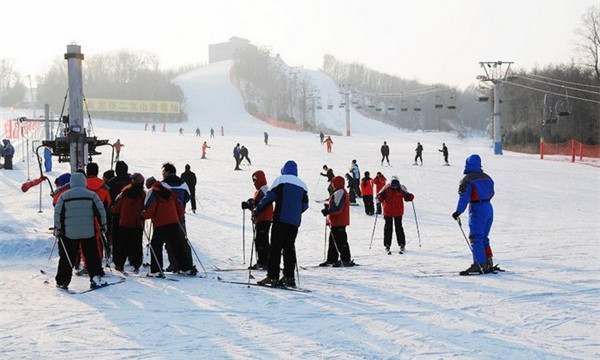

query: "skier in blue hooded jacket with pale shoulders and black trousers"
xmin=252 ymin=160 xmax=308 ymax=287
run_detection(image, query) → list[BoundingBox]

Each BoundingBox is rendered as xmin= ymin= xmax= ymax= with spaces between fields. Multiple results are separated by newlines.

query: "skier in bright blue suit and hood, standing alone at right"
xmin=452 ymin=154 xmax=496 ymax=275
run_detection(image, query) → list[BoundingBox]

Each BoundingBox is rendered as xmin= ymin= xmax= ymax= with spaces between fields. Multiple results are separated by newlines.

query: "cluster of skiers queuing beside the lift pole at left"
xmin=53 ymin=161 xmax=197 ymax=289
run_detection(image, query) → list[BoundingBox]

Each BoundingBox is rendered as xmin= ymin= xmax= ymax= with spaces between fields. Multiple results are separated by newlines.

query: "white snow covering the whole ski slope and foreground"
xmin=0 ymin=62 xmax=600 ymax=359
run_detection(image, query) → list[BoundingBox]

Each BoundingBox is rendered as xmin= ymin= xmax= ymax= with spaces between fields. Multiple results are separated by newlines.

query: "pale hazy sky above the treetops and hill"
xmin=0 ymin=0 xmax=600 ymax=86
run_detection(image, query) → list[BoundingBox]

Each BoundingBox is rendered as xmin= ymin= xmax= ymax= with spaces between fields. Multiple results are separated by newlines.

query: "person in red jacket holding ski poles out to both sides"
xmin=377 ymin=176 xmax=415 ymax=254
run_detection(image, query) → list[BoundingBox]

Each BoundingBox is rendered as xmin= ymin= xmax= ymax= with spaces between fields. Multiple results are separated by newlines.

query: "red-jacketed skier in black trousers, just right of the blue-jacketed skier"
xmin=319 ymin=176 xmax=355 ymax=267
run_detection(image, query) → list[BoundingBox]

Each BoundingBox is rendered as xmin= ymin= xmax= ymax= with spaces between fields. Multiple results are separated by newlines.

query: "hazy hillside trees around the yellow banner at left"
xmin=36 ymin=50 xmax=187 ymax=121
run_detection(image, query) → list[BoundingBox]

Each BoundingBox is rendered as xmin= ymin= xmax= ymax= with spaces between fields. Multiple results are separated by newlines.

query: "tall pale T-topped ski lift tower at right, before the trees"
xmin=477 ymin=61 xmax=514 ymax=155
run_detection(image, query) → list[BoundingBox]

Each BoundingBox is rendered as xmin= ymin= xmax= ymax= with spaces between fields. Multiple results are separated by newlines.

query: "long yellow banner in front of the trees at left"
xmin=86 ymin=98 xmax=180 ymax=114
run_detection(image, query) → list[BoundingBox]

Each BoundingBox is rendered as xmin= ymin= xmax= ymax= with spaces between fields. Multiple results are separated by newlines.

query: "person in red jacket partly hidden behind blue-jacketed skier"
xmin=242 ymin=170 xmax=273 ymax=270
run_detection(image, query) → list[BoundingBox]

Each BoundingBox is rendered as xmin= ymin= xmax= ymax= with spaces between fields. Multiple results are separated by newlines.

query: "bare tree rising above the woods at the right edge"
xmin=575 ymin=6 xmax=600 ymax=84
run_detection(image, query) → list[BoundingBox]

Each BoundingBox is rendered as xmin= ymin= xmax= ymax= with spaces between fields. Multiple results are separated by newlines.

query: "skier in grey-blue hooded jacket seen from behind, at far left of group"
xmin=54 ymin=173 xmax=106 ymax=289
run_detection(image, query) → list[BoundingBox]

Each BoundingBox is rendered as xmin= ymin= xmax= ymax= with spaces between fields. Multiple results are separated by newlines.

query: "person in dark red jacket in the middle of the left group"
xmin=112 ymin=173 xmax=146 ymax=273
